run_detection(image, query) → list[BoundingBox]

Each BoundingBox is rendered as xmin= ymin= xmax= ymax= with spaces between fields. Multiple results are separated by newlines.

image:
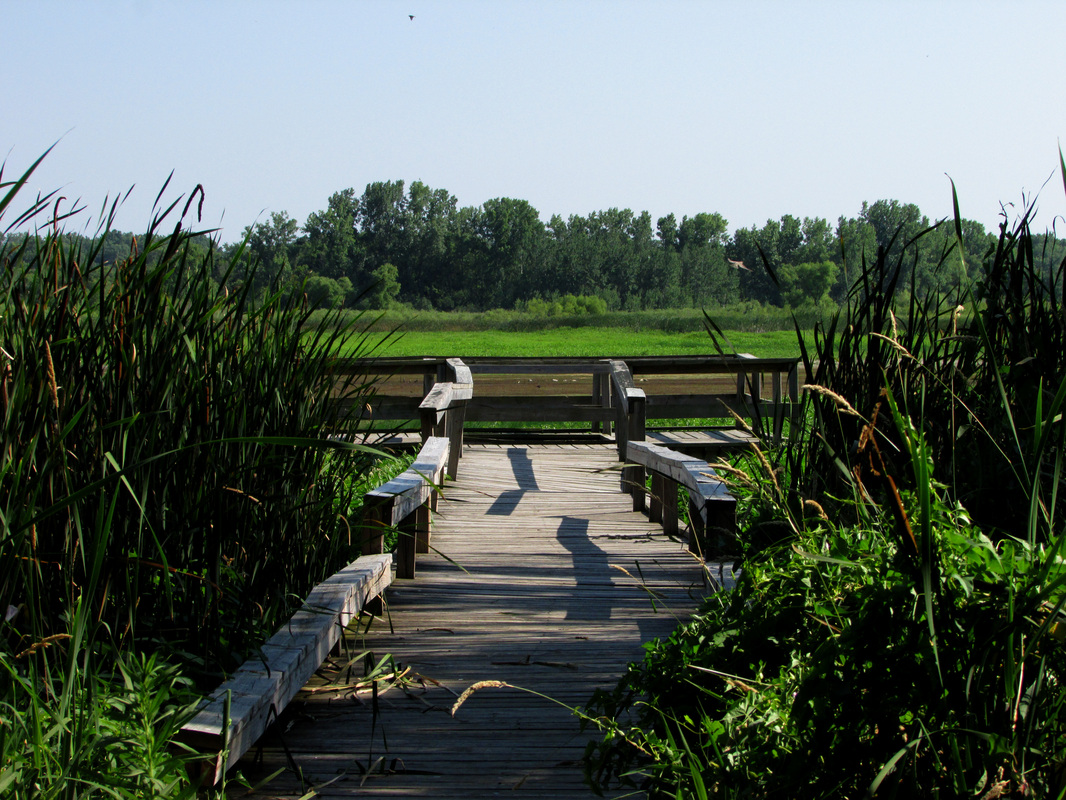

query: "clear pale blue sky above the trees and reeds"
xmin=0 ymin=0 xmax=1066 ymax=241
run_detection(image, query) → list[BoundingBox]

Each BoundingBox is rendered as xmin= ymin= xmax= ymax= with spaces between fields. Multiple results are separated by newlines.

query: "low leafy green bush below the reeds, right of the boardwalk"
xmin=588 ymin=480 xmax=1066 ymax=798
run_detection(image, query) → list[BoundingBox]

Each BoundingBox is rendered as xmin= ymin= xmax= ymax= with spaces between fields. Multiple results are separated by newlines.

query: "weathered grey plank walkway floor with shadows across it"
xmin=240 ymin=445 xmax=704 ymax=800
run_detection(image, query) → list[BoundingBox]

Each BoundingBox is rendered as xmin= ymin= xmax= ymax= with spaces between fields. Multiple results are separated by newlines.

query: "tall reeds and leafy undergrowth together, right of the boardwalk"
xmin=586 ymin=172 xmax=1066 ymax=798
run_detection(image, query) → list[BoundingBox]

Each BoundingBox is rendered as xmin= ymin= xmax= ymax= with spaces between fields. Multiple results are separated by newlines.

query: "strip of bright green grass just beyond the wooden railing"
xmin=362 ymin=327 xmax=800 ymax=358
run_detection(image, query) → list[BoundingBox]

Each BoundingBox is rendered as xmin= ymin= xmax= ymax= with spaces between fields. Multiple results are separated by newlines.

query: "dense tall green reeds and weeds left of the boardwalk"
xmin=0 ymin=153 xmax=388 ymax=798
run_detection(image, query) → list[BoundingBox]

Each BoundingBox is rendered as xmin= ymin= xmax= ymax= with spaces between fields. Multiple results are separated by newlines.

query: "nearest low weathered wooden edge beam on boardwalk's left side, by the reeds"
xmin=179 ymin=554 xmax=392 ymax=785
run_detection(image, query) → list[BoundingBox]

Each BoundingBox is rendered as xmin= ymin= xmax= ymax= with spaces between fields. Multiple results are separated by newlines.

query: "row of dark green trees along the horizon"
xmin=6 ymin=180 xmax=1066 ymax=311
